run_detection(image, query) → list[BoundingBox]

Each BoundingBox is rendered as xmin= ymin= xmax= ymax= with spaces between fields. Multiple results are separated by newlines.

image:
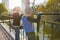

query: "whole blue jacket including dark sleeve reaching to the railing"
xmin=22 ymin=14 xmax=41 ymax=32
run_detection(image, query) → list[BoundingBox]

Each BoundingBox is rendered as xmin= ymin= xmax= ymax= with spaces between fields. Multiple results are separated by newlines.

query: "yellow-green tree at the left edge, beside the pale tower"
xmin=0 ymin=3 xmax=11 ymax=20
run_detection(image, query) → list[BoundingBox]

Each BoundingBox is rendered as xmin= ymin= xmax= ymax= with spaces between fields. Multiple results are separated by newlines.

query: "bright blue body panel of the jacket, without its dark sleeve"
xmin=22 ymin=16 xmax=34 ymax=32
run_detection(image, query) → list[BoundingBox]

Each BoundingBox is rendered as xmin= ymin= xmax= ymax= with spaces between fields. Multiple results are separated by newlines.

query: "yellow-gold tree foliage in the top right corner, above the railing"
xmin=46 ymin=0 xmax=60 ymax=13
